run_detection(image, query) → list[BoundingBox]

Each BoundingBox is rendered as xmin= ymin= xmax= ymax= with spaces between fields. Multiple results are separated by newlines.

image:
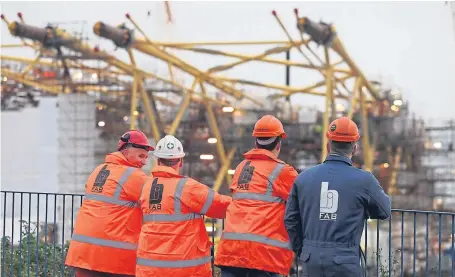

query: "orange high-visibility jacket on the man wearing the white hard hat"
xmin=136 ymin=166 xmax=231 ymax=277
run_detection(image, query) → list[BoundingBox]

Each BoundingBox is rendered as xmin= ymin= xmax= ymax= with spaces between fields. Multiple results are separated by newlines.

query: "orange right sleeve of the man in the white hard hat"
xmin=181 ymin=180 xmax=232 ymax=218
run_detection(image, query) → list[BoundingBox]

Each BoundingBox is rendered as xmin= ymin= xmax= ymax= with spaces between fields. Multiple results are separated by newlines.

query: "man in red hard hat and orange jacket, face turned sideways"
xmin=65 ymin=130 xmax=154 ymax=277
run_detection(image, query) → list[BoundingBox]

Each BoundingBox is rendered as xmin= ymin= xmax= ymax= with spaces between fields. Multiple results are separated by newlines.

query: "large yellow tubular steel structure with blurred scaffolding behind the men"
xmin=2 ymin=8 xmax=452 ymax=244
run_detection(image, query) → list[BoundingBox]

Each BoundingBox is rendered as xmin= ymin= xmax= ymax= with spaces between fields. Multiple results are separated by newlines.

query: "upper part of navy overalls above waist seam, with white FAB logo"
xmin=296 ymin=156 xmax=389 ymax=245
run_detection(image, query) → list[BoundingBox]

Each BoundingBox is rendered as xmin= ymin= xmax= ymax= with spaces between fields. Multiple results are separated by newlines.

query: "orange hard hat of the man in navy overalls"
xmin=325 ymin=116 xmax=360 ymax=142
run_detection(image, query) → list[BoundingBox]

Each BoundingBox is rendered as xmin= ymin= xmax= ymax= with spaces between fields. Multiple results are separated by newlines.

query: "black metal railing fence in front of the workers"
xmin=1 ymin=191 xmax=455 ymax=277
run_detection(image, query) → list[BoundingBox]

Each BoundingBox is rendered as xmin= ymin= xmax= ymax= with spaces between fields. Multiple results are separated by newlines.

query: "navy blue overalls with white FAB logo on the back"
xmin=292 ymin=155 xmax=390 ymax=277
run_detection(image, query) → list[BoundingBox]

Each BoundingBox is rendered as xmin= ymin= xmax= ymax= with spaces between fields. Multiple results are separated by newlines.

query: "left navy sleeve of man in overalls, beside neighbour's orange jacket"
xmin=284 ymin=181 xmax=303 ymax=255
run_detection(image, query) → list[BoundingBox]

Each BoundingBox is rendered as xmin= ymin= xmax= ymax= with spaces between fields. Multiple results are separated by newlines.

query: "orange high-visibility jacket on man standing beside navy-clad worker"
xmin=215 ymin=149 xmax=298 ymax=275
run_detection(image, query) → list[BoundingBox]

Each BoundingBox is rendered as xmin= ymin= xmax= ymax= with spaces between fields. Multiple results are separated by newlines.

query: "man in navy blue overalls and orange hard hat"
xmin=284 ymin=117 xmax=391 ymax=277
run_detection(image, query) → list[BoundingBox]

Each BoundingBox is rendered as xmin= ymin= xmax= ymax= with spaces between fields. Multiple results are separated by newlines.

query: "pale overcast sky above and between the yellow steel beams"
xmin=1 ymin=1 xmax=455 ymax=118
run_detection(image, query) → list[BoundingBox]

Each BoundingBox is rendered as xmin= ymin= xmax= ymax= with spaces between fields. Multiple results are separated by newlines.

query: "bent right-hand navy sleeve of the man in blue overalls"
xmin=365 ymin=173 xmax=392 ymax=219
